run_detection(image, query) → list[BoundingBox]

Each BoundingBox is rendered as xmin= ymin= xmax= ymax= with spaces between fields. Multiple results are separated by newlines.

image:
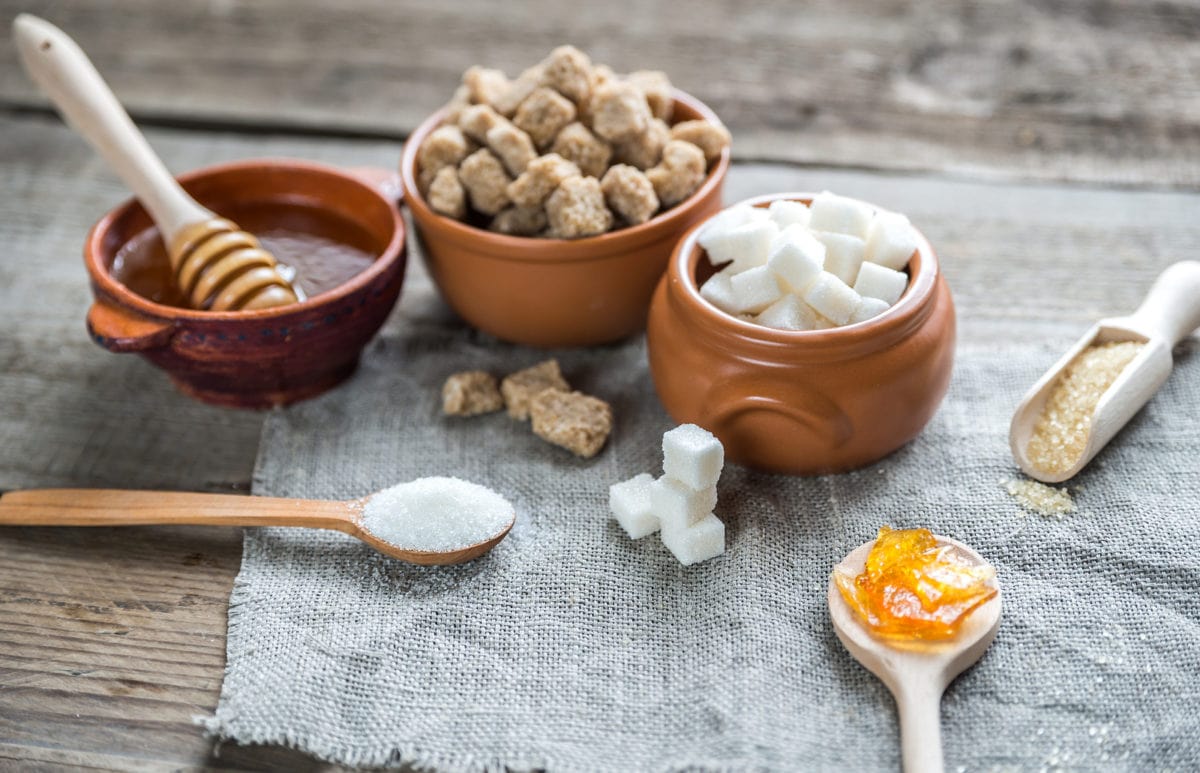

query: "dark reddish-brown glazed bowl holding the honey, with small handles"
xmin=84 ymin=160 xmax=406 ymax=408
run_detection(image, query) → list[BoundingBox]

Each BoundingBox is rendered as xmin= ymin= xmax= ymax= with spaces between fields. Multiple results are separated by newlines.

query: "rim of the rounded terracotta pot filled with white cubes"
xmin=664 ymin=191 xmax=941 ymax=349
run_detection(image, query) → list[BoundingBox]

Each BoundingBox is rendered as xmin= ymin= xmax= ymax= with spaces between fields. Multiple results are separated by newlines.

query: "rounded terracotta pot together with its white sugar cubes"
xmin=647 ymin=191 xmax=955 ymax=474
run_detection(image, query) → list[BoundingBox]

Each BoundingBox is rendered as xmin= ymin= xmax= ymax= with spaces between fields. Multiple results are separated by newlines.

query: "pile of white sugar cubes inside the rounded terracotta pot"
xmin=697 ymin=191 xmax=917 ymax=330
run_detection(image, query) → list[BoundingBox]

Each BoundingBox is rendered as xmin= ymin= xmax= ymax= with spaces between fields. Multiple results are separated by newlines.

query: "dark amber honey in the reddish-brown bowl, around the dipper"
xmin=110 ymin=202 xmax=383 ymax=308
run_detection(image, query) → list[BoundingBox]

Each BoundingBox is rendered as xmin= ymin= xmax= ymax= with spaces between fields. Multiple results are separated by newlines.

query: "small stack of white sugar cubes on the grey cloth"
xmin=608 ymin=424 xmax=725 ymax=567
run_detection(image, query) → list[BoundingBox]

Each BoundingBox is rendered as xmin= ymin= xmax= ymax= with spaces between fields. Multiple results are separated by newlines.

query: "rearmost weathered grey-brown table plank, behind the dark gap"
xmin=0 ymin=0 xmax=1200 ymax=187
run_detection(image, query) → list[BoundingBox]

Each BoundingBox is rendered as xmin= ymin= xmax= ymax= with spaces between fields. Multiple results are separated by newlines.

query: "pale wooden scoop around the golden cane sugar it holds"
xmin=1008 ymin=260 xmax=1200 ymax=483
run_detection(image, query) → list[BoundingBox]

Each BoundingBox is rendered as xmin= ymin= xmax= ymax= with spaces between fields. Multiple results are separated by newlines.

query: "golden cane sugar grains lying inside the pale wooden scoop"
xmin=1025 ymin=341 xmax=1145 ymax=474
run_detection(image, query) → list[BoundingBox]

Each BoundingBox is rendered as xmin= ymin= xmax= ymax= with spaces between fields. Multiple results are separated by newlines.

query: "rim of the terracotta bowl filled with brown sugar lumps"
xmin=400 ymin=89 xmax=731 ymax=263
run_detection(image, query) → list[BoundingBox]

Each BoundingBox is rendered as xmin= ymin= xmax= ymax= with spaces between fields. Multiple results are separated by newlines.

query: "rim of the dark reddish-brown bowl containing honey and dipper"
xmin=83 ymin=157 xmax=407 ymax=322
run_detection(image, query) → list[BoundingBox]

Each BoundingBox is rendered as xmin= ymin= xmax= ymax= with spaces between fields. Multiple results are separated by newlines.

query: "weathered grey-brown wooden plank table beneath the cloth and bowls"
xmin=0 ymin=0 xmax=1200 ymax=769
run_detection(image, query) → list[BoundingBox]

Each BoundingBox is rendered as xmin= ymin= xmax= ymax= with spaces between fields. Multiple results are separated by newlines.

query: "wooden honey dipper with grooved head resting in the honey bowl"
xmin=13 ymin=13 xmax=300 ymax=311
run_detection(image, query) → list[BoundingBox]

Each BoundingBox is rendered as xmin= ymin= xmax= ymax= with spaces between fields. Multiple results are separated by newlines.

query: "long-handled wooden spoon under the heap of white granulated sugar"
xmin=0 ymin=489 xmax=516 ymax=564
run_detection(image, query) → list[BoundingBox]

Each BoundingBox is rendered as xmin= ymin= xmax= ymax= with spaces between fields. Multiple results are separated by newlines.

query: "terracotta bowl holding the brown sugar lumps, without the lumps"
xmin=401 ymin=91 xmax=730 ymax=347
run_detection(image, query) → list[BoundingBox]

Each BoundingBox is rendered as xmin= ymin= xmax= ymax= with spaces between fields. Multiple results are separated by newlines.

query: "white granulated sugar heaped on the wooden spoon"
xmin=362 ymin=477 xmax=515 ymax=552
